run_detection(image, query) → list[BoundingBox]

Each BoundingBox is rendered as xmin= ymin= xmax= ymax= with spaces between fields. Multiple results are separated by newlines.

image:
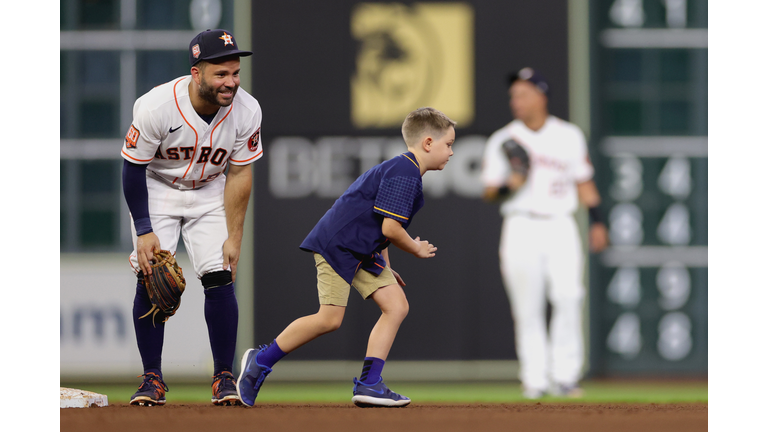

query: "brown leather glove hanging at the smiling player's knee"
xmin=139 ymin=250 xmax=187 ymax=325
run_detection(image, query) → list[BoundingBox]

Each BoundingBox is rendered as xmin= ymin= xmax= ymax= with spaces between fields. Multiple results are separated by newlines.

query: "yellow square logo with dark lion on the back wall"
xmin=351 ymin=3 xmax=475 ymax=128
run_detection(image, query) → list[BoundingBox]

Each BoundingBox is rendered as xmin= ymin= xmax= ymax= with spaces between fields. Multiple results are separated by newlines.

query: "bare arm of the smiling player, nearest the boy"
xmin=222 ymin=164 xmax=252 ymax=281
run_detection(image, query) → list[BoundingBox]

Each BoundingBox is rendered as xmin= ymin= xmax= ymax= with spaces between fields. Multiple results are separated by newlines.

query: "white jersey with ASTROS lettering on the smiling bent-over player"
xmin=121 ymin=75 xmax=264 ymax=189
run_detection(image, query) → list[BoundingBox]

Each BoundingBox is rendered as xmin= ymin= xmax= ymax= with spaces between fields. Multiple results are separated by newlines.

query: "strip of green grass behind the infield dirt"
xmin=61 ymin=381 xmax=708 ymax=403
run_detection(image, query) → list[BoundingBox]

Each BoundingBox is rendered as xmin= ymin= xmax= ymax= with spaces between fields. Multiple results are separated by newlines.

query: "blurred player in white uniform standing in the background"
xmin=482 ymin=68 xmax=607 ymax=399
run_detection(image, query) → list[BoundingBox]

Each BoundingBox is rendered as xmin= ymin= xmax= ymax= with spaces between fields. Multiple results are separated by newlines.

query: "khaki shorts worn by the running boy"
xmin=314 ymin=253 xmax=397 ymax=306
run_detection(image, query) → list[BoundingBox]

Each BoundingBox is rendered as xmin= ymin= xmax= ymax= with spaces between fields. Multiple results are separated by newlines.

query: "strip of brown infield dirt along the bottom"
xmin=60 ymin=403 xmax=708 ymax=432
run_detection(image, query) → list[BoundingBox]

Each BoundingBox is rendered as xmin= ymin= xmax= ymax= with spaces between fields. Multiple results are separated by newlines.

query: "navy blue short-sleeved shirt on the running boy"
xmin=301 ymin=152 xmax=424 ymax=284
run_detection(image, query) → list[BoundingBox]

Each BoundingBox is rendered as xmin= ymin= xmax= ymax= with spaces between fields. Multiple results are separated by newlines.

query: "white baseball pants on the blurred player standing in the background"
xmin=499 ymin=214 xmax=584 ymax=391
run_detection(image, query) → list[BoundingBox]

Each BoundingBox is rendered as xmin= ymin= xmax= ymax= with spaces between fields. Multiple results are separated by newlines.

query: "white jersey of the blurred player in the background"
xmin=481 ymin=115 xmax=594 ymax=216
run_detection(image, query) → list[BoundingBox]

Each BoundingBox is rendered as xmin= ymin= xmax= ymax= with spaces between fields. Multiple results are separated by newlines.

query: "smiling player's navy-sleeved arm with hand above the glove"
xmin=123 ymin=160 xmax=161 ymax=275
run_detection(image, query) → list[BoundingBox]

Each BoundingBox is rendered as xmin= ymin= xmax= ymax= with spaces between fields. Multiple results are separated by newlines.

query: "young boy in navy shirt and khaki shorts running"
xmin=237 ymin=108 xmax=456 ymax=407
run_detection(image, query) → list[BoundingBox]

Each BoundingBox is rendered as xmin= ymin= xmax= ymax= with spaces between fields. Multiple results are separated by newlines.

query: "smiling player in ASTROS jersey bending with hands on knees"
xmin=121 ymin=30 xmax=263 ymax=405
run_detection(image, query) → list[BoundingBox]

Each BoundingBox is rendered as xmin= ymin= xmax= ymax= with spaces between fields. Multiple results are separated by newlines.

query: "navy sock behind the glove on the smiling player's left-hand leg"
xmin=133 ymin=282 xmax=165 ymax=378
